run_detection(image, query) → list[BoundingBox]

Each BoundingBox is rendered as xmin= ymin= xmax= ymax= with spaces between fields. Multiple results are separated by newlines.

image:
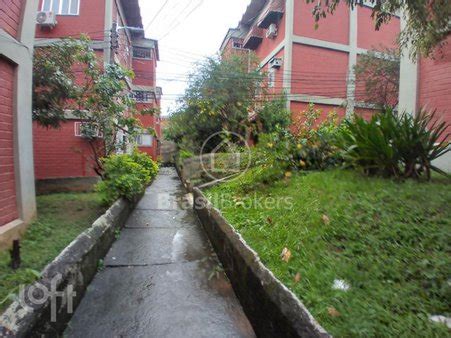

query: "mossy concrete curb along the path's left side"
xmin=0 ymin=198 xmax=139 ymax=337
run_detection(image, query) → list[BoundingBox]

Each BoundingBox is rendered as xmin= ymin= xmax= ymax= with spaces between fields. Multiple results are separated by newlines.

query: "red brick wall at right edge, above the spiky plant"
xmin=418 ymin=35 xmax=451 ymax=140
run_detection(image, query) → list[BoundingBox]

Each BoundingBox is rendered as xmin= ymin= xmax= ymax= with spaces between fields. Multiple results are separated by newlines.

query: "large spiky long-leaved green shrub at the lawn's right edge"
xmin=337 ymin=110 xmax=450 ymax=179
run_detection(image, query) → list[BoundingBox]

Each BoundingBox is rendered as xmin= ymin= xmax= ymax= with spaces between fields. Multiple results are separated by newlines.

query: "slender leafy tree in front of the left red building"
xmin=33 ymin=37 xmax=153 ymax=176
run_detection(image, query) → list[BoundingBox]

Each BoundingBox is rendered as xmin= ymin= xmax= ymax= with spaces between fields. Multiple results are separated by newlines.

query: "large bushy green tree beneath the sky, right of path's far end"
xmin=167 ymin=54 xmax=264 ymax=152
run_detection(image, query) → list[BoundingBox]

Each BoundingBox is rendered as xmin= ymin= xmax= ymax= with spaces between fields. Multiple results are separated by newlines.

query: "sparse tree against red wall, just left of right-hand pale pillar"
xmin=354 ymin=48 xmax=400 ymax=108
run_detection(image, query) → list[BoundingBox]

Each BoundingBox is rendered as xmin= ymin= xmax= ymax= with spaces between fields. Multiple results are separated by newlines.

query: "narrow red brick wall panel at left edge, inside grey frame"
xmin=0 ymin=58 xmax=19 ymax=226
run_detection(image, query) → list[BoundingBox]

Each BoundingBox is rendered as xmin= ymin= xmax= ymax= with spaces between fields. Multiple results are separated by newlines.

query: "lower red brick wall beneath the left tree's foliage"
xmin=33 ymin=120 xmax=100 ymax=179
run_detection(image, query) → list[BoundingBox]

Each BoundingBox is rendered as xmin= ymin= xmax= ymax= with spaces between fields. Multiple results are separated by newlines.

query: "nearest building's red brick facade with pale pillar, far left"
xmin=0 ymin=0 xmax=37 ymax=249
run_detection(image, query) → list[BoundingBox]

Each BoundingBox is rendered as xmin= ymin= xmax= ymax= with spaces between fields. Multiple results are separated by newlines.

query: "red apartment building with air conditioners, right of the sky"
xmin=221 ymin=0 xmax=400 ymax=118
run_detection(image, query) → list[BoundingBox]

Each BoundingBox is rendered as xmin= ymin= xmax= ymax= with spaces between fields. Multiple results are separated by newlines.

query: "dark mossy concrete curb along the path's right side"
xmin=192 ymin=188 xmax=331 ymax=337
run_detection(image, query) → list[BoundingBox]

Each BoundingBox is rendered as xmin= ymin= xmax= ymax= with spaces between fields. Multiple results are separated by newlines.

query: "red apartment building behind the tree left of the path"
xmin=33 ymin=0 xmax=161 ymax=187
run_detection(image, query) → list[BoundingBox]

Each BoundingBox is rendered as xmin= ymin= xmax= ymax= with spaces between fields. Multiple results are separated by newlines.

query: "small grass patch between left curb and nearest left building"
xmin=0 ymin=193 xmax=105 ymax=313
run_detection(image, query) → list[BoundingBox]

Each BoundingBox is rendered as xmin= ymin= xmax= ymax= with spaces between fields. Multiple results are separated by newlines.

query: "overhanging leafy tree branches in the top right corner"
xmin=306 ymin=0 xmax=451 ymax=58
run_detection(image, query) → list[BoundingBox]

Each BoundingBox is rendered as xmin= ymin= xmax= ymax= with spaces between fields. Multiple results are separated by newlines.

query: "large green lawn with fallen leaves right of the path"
xmin=206 ymin=170 xmax=451 ymax=337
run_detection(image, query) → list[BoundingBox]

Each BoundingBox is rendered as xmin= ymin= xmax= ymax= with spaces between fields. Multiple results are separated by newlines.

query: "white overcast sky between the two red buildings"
xmin=139 ymin=0 xmax=250 ymax=115
